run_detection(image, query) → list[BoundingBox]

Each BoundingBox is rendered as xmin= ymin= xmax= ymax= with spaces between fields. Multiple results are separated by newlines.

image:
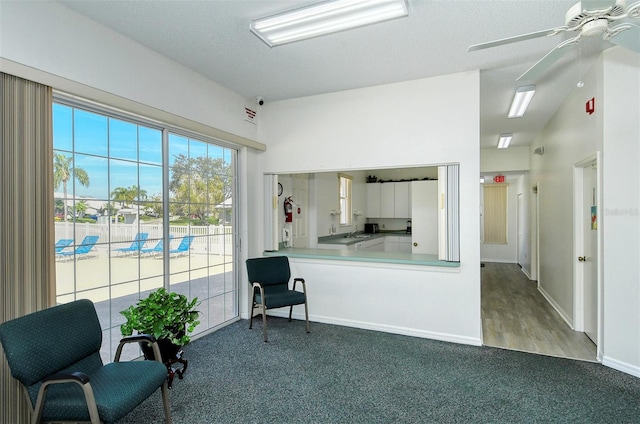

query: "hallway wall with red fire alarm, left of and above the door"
xmin=530 ymin=50 xmax=603 ymax=326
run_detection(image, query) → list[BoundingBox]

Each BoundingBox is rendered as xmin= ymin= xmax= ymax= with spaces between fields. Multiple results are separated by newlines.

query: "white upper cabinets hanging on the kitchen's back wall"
xmin=367 ymin=182 xmax=411 ymax=218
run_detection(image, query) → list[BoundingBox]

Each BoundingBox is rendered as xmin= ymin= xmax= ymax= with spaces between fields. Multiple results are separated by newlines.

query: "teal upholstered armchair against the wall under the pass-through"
xmin=247 ymin=256 xmax=309 ymax=342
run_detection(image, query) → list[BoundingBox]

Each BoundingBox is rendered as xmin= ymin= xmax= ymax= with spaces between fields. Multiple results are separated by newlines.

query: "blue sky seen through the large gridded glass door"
xmin=53 ymin=103 xmax=232 ymax=200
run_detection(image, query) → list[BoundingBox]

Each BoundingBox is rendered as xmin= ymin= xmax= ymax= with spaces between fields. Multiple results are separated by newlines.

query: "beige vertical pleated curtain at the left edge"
xmin=0 ymin=73 xmax=55 ymax=423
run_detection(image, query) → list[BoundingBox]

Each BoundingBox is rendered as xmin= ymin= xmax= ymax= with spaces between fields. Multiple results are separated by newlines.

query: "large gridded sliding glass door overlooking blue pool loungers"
xmin=52 ymin=99 xmax=238 ymax=361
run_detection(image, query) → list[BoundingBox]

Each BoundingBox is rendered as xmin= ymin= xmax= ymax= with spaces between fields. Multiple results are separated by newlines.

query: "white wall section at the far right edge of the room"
xmin=596 ymin=48 xmax=640 ymax=377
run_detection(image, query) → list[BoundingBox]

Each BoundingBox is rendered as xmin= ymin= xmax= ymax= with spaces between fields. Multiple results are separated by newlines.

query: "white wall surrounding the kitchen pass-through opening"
xmin=249 ymin=72 xmax=481 ymax=344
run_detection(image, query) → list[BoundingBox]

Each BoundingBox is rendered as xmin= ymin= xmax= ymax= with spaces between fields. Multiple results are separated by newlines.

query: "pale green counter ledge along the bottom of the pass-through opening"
xmin=264 ymin=245 xmax=460 ymax=268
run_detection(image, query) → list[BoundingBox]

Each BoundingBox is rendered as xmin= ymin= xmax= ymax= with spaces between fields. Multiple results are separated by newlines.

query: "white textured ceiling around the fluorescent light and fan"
xmin=60 ymin=0 xmax=610 ymax=148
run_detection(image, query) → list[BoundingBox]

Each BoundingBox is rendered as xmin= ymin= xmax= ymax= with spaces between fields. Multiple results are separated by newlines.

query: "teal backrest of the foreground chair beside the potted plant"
xmin=0 ymin=300 xmax=102 ymax=387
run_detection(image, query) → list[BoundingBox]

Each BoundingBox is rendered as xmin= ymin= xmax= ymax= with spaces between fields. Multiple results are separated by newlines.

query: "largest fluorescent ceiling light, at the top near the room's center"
xmin=250 ymin=0 xmax=409 ymax=47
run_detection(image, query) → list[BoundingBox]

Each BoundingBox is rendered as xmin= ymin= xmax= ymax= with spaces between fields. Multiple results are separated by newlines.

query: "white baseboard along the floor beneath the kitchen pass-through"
xmin=269 ymin=311 xmax=482 ymax=346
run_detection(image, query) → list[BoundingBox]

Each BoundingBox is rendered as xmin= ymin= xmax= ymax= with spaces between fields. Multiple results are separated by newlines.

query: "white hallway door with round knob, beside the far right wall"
xmin=578 ymin=161 xmax=600 ymax=345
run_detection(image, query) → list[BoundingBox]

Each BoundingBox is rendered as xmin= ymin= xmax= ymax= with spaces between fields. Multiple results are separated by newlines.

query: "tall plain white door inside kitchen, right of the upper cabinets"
xmin=411 ymin=181 xmax=438 ymax=255
